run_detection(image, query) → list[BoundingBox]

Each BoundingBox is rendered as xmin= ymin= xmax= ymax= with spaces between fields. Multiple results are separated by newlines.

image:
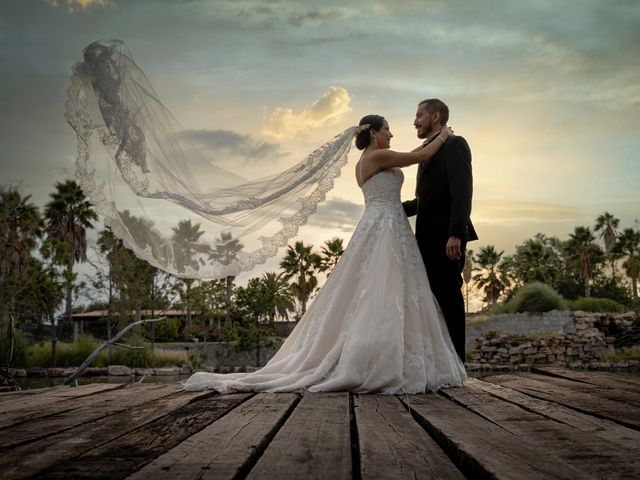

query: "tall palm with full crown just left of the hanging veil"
xmin=45 ymin=180 xmax=98 ymax=337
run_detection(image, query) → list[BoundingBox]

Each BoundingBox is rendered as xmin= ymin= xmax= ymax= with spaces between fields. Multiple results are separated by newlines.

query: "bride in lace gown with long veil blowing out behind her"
xmin=65 ymin=40 xmax=466 ymax=394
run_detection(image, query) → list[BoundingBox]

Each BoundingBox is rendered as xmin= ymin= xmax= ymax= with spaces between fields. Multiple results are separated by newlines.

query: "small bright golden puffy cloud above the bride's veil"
xmin=262 ymin=87 xmax=351 ymax=138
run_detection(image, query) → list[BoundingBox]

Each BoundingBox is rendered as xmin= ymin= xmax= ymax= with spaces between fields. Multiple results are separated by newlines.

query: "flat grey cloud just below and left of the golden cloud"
xmin=180 ymin=130 xmax=288 ymax=160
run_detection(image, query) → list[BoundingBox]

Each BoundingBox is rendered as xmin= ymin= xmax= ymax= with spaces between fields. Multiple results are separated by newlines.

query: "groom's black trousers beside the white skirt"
xmin=417 ymin=235 xmax=467 ymax=363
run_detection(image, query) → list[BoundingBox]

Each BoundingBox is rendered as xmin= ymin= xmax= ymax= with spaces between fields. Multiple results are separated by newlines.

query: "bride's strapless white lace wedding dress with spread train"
xmin=184 ymin=168 xmax=466 ymax=394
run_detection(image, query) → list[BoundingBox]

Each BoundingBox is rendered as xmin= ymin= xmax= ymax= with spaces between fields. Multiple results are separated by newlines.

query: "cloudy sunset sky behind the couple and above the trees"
xmin=0 ymin=0 xmax=640 ymax=284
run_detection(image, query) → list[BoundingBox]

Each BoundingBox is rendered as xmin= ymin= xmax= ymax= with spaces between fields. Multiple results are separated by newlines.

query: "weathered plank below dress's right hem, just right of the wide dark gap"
xmin=401 ymin=394 xmax=591 ymax=480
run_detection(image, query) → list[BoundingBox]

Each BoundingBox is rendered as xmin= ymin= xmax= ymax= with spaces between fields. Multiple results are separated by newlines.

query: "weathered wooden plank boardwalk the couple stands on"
xmin=0 ymin=368 xmax=640 ymax=480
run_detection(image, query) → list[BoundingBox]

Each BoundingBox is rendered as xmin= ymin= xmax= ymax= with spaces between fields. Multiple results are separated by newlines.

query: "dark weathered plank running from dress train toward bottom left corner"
xmin=16 ymin=392 xmax=252 ymax=479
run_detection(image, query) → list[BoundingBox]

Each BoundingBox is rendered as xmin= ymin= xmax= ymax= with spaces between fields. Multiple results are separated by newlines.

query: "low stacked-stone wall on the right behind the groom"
xmin=471 ymin=312 xmax=637 ymax=367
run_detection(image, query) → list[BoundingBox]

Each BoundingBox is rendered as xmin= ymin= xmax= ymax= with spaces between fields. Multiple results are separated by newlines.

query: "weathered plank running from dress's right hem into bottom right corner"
xmin=442 ymin=382 xmax=640 ymax=479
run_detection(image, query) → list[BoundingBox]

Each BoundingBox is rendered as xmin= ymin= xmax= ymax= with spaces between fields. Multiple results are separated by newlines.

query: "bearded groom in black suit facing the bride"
xmin=402 ymin=98 xmax=478 ymax=362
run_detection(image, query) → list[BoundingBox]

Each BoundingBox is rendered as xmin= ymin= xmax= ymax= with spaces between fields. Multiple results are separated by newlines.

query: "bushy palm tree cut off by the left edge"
xmin=0 ymin=187 xmax=42 ymax=332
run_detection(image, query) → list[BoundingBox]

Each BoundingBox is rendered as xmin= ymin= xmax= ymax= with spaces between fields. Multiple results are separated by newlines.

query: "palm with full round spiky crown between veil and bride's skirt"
xmin=280 ymin=242 xmax=322 ymax=315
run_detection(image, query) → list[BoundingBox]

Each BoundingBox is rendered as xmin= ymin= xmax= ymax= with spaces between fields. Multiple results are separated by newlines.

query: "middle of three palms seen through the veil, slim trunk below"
xmin=171 ymin=219 xmax=210 ymax=332
